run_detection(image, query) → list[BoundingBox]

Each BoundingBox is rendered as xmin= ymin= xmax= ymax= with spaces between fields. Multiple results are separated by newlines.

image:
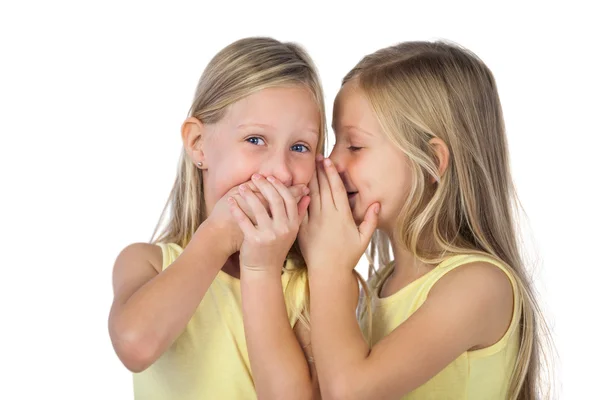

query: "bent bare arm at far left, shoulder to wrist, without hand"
xmin=109 ymin=221 xmax=230 ymax=372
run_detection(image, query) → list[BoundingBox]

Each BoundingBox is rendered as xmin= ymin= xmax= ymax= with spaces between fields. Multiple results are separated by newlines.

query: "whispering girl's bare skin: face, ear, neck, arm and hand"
xmin=299 ymin=81 xmax=513 ymax=399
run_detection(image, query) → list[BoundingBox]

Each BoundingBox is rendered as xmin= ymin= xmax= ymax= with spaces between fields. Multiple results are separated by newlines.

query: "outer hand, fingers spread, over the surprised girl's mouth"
xmin=228 ymin=174 xmax=310 ymax=275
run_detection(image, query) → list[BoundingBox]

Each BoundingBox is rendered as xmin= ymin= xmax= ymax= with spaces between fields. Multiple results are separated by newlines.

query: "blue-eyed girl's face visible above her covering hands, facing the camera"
xmin=202 ymin=87 xmax=320 ymax=213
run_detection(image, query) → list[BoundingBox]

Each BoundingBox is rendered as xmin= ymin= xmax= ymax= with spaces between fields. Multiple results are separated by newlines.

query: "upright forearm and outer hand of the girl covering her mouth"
xmin=231 ymin=175 xmax=312 ymax=400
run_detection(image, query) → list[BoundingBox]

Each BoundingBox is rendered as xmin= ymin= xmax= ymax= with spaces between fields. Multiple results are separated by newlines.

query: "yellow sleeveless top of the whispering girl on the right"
xmin=360 ymin=255 xmax=522 ymax=400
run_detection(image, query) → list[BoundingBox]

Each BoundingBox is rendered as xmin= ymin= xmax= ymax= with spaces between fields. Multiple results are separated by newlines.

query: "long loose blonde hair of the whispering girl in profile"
xmin=350 ymin=42 xmax=556 ymax=400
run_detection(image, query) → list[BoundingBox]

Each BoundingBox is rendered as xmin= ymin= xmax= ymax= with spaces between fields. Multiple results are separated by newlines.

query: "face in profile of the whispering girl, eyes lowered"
xmin=330 ymin=81 xmax=411 ymax=234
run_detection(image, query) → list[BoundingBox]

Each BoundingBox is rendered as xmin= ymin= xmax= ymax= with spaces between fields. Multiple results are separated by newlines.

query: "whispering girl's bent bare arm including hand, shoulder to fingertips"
xmin=300 ymin=160 xmax=513 ymax=399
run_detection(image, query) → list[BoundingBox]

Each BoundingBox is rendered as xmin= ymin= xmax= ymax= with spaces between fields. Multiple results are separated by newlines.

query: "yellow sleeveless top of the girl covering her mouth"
xmin=133 ymin=243 xmax=306 ymax=400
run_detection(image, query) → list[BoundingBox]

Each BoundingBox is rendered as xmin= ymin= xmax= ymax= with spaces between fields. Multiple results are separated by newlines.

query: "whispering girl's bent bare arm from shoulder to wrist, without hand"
xmin=310 ymin=263 xmax=512 ymax=399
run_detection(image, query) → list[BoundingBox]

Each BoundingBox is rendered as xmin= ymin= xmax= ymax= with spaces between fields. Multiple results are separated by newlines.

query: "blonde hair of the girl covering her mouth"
xmin=151 ymin=37 xmax=326 ymax=324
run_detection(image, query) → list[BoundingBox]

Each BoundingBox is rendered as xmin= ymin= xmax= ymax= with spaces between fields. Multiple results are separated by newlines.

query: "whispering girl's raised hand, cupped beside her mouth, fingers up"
xmin=298 ymin=159 xmax=380 ymax=271
